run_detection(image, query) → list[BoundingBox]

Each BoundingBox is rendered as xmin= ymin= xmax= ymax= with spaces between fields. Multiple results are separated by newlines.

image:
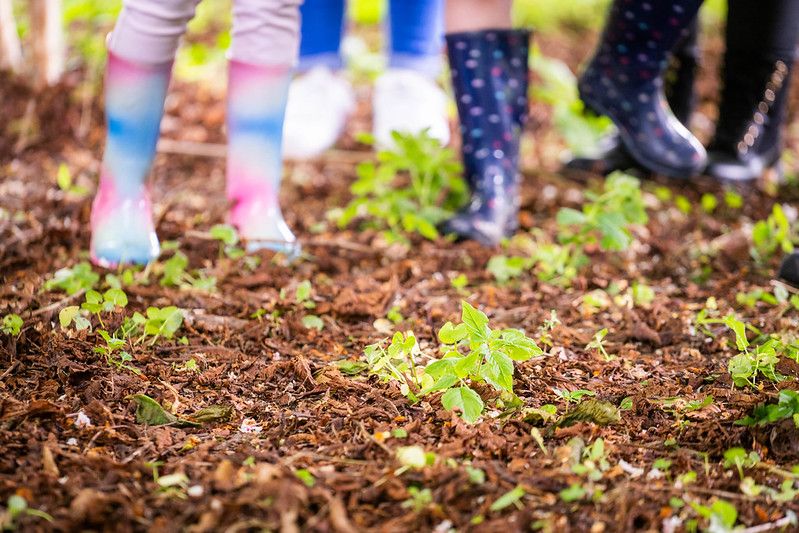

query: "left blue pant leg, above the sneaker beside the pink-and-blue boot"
xmin=300 ymin=0 xmax=344 ymax=70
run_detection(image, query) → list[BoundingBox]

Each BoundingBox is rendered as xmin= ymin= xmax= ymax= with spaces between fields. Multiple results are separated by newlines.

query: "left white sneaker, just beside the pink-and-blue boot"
xmin=283 ymin=67 xmax=355 ymax=159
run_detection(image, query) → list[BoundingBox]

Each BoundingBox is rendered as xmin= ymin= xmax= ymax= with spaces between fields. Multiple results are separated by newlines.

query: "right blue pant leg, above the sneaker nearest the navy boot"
xmin=388 ymin=0 xmax=444 ymax=76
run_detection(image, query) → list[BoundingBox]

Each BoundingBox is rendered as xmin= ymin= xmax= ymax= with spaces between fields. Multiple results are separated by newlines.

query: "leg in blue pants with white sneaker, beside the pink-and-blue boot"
xmin=283 ymin=0 xmax=355 ymax=159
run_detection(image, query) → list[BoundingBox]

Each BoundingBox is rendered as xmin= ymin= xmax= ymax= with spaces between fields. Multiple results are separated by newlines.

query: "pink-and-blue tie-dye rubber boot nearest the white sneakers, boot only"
xmin=227 ymin=60 xmax=299 ymax=258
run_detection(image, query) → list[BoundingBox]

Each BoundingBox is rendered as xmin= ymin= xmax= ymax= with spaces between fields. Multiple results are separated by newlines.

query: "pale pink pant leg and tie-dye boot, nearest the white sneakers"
xmin=227 ymin=0 xmax=301 ymax=254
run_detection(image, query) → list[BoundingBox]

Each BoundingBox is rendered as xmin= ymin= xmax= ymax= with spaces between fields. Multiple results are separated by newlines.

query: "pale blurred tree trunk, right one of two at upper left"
xmin=28 ymin=0 xmax=66 ymax=86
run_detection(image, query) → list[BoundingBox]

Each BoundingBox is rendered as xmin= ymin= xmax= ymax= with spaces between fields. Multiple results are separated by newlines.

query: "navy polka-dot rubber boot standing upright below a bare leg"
xmin=441 ymin=30 xmax=531 ymax=246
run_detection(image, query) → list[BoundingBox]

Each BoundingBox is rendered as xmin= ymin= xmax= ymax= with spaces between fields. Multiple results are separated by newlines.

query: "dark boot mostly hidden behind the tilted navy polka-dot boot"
xmin=566 ymin=20 xmax=699 ymax=176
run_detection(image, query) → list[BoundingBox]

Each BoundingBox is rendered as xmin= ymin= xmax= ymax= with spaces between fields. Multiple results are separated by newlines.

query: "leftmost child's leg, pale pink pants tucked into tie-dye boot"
xmin=91 ymin=0 xmax=199 ymax=266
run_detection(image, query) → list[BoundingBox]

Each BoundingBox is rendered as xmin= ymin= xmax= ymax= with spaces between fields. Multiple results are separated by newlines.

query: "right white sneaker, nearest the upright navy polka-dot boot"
xmin=373 ymin=69 xmax=449 ymax=149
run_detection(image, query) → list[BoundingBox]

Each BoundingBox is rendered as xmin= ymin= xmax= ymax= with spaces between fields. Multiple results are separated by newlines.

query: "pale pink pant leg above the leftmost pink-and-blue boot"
xmin=108 ymin=0 xmax=200 ymax=64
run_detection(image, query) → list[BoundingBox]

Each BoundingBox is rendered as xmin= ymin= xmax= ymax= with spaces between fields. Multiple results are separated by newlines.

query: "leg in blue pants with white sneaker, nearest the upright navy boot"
xmin=373 ymin=0 xmax=449 ymax=147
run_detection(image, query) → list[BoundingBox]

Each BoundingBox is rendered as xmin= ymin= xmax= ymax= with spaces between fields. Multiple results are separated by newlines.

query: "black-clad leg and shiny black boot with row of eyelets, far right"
xmin=706 ymin=0 xmax=799 ymax=183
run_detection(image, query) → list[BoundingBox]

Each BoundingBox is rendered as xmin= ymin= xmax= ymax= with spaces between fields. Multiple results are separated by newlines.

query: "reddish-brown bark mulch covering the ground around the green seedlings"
xmin=0 ymin=26 xmax=799 ymax=532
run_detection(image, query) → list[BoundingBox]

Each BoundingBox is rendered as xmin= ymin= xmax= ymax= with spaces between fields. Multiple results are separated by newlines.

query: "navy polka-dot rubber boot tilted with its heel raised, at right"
xmin=579 ymin=0 xmax=707 ymax=178
